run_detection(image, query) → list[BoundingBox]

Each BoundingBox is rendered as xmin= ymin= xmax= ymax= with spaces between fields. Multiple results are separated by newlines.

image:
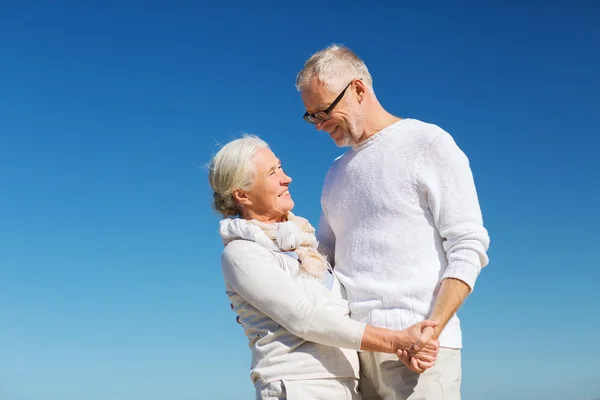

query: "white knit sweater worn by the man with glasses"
xmin=318 ymin=119 xmax=489 ymax=348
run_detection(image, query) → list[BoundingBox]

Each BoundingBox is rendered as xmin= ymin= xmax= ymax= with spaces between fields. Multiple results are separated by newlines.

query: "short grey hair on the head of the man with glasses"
xmin=296 ymin=44 xmax=373 ymax=93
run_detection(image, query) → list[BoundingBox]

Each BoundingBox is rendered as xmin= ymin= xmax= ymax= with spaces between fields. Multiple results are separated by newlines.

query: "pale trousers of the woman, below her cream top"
xmin=256 ymin=378 xmax=362 ymax=400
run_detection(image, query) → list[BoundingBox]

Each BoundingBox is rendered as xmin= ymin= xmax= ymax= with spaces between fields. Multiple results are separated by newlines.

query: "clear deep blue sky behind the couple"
xmin=0 ymin=1 xmax=600 ymax=400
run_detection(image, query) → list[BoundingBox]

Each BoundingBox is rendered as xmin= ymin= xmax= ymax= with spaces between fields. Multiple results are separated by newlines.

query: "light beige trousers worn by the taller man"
xmin=358 ymin=348 xmax=462 ymax=400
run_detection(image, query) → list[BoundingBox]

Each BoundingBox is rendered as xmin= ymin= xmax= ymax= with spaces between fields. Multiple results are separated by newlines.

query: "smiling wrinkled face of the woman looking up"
xmin=238 ymin=148 xmax=294 ymax=222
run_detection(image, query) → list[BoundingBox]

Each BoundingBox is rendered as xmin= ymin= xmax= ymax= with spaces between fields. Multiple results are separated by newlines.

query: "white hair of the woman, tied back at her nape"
xmin=208 ymin=134 xmax=269 ymax=217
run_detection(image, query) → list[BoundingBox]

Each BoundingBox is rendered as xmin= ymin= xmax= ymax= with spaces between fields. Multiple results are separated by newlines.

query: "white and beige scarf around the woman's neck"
xmin=219 ymin=212 xmax=329 ymax=279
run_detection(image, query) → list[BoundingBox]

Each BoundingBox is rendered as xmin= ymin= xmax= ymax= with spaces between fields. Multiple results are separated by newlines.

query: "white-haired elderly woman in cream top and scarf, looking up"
xmin=209 ymin=136 xmax=437 ymax=400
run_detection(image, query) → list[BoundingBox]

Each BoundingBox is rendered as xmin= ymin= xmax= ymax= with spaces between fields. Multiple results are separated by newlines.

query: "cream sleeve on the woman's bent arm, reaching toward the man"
xmin=221 ymin=241 xmax=366 ymax=350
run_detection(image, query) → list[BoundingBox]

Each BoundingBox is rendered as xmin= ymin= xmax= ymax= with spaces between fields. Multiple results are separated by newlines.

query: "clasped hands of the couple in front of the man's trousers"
xmin=396 ymin=321 xmax=440 ymax=374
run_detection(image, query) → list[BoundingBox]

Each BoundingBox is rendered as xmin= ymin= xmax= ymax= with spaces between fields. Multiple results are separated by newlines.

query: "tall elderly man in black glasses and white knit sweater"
xmin=296 ymin=45 xmax=489 ymax=400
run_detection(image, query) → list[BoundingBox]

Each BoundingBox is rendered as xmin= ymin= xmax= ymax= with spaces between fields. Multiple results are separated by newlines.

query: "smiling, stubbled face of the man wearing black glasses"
xmin=300 ymin=77 xmax=365 ymax=147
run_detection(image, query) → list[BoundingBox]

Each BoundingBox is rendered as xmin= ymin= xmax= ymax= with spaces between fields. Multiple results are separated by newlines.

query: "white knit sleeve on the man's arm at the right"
xmin=417 ymin=132 xmax=490 ymax=291
